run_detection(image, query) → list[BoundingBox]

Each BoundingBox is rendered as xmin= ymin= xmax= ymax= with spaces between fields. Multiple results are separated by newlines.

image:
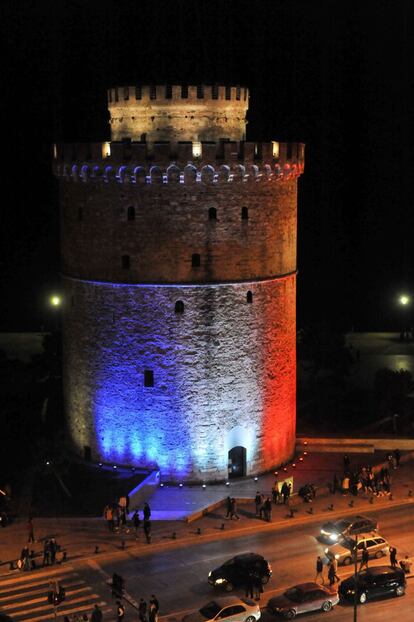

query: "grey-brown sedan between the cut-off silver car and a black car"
xmin=267 ymin=583 xmax=339 ymax=620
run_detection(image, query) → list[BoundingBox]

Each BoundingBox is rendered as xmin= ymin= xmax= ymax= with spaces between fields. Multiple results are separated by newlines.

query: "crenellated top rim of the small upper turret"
xmin=108 ymin=84 xmax=249 ymax=108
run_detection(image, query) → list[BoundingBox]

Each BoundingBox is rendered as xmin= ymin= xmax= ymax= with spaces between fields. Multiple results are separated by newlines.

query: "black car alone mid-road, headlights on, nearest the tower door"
xmin=208 ymin=553 xmax=272 ymax=592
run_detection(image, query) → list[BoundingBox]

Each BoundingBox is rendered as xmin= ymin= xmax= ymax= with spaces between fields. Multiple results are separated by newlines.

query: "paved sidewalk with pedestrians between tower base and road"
xmin=0 ymin=454 xmax=414 ymax=575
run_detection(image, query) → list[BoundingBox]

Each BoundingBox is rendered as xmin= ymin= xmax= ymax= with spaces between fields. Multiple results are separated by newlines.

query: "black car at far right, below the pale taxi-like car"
xmin=339 ymin=566 xmax=406 ymax=604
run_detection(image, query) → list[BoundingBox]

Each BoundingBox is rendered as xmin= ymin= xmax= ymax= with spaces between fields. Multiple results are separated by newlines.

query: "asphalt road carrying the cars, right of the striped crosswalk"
xmin=90 ymin=506 xmax=414 ymax=622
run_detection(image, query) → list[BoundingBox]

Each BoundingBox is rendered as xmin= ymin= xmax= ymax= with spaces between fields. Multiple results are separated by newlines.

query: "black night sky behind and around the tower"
xmin=0 ymin=0 xmax=414 ymax=330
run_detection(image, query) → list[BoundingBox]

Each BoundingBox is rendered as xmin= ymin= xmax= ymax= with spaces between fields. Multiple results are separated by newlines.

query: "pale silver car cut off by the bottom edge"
xmin=182 ymin=596 xmax=261 ymax=622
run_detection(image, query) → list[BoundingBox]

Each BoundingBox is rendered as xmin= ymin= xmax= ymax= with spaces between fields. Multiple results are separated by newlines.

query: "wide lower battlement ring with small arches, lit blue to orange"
xmin=54 ymin=141 xmax=305 ymax=184
